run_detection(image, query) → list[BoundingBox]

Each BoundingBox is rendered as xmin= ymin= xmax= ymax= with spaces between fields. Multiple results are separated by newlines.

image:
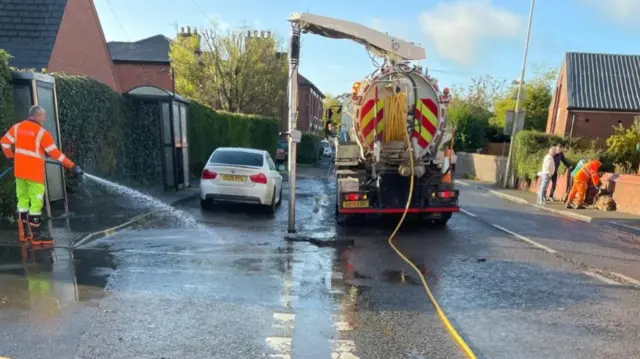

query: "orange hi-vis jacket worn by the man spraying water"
xmin=0 ymin=120 xmax=75 ymax=184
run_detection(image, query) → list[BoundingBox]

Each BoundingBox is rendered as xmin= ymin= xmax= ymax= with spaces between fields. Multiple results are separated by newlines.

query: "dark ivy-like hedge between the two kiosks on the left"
xmin=52 ymin=74 xmax=135 ymax=189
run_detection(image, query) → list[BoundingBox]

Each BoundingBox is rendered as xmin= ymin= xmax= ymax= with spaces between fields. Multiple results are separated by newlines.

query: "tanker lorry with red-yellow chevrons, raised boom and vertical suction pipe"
xmin=287 ymin=13 xmax=460 ymax=228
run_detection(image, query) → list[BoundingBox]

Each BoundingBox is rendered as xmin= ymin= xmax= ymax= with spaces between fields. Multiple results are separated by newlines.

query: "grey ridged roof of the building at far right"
xmin=565 ymin=52 xmax=640 ymax=112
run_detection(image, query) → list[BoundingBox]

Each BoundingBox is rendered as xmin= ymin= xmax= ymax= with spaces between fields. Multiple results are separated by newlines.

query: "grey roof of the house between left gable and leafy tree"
xmin=107 ymin=35 xmax=171 ymax=63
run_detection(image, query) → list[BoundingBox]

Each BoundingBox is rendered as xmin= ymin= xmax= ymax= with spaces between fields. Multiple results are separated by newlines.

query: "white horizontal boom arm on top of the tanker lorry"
xmin=289 ymin=13 xmax=426 ymax=60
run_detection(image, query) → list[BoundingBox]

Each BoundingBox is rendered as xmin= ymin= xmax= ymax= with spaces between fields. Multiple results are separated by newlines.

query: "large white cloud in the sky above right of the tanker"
xmin=420 ymin=0 xmax=522 ymax=66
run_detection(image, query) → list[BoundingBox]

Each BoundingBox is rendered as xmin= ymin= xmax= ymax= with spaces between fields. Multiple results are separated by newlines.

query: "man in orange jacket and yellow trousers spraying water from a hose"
xmin=0 ymin=106 xmax=83 ymax=245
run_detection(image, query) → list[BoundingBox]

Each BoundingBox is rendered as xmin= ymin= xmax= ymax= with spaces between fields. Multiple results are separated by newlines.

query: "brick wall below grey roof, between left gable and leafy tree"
xmin=115 ymin=62 xmax=173 ymax=92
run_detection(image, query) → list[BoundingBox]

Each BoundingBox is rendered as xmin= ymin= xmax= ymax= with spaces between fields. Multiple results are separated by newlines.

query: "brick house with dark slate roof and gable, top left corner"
xmin=0 ymin=0 xmax=120 ymax=91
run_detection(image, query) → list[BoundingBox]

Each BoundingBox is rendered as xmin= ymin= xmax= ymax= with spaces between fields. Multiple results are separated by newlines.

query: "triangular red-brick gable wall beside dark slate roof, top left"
xmin=47 ymin=0 xmax=120 ymax=92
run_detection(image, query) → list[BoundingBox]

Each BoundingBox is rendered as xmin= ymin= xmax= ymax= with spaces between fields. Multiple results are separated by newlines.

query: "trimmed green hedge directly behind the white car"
xmin=188 ymin=101 xmax=280 ymax=175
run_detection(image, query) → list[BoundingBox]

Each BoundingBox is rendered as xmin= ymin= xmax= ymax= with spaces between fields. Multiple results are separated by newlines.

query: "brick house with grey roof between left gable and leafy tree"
xmin=107 ymin=35 xmax=173 ymax=92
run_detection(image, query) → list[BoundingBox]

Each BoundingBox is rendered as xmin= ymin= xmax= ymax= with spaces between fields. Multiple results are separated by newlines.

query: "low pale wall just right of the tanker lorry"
xmin=456 ymin=152 xmax=507 ymax=183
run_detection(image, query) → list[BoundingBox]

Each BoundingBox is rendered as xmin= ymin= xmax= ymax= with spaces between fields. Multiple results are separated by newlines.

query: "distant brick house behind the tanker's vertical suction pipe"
xmin=280 ymin=74 xmax=325 ymax=133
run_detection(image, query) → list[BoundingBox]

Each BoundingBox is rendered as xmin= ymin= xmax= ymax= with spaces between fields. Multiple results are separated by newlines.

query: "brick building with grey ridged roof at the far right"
xmin=546 ymin=52 xmax=640 ymax=140
